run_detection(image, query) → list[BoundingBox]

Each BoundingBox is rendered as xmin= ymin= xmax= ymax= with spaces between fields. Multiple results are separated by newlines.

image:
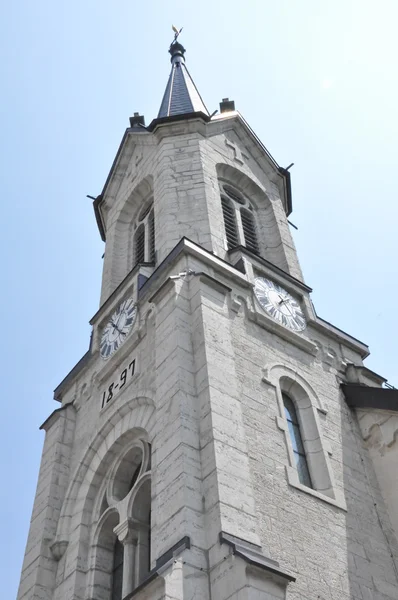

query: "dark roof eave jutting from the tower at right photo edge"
xmin=341 ymin=383 xmax=398 ymax=412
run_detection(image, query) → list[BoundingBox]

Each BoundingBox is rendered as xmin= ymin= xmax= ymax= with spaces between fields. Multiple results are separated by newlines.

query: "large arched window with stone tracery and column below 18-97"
xmin=88 ymin=438 xmax=151 ymax=600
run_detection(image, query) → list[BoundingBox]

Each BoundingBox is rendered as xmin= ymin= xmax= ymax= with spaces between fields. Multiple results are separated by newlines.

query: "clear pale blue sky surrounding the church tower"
xmin=0 ymin=0 xmax=398 ymax=600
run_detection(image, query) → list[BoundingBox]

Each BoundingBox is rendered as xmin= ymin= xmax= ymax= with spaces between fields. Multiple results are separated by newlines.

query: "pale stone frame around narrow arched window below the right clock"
xmin=263 ymin=365 xmax=347 ymax=510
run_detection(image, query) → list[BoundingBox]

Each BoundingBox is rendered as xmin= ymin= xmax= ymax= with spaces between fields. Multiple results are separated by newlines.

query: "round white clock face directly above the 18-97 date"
xmin=100 ymin=298 xmax=137 ymax=360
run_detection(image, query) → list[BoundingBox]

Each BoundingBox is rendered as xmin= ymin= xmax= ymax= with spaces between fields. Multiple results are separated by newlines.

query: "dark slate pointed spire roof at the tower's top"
xmin=158 ymin=42 xmax=210 ymax=119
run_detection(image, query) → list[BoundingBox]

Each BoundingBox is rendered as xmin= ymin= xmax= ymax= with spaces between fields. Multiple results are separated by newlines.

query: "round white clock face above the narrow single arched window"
xmin=254 ymin=277 xmax=306 ymax=331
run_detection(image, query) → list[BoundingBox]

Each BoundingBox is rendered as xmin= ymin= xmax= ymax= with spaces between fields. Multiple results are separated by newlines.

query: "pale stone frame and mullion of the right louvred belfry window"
xmin=218 ymin=184 xmax=260 ymax=255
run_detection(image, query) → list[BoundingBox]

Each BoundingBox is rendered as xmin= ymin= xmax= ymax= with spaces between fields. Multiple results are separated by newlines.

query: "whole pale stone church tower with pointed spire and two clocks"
xmin=18 ymin=36 xmax=398 ymax=600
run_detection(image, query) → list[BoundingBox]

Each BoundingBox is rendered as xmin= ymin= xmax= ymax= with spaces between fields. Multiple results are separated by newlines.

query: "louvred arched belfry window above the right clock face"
xmin=220 ymin=185 xmax=259 ymax=254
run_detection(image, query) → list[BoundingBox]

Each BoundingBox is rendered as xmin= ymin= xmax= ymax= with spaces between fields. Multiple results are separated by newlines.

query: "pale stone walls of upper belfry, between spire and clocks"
xmin=99 ymin=113 xmax=302 ymax=304
